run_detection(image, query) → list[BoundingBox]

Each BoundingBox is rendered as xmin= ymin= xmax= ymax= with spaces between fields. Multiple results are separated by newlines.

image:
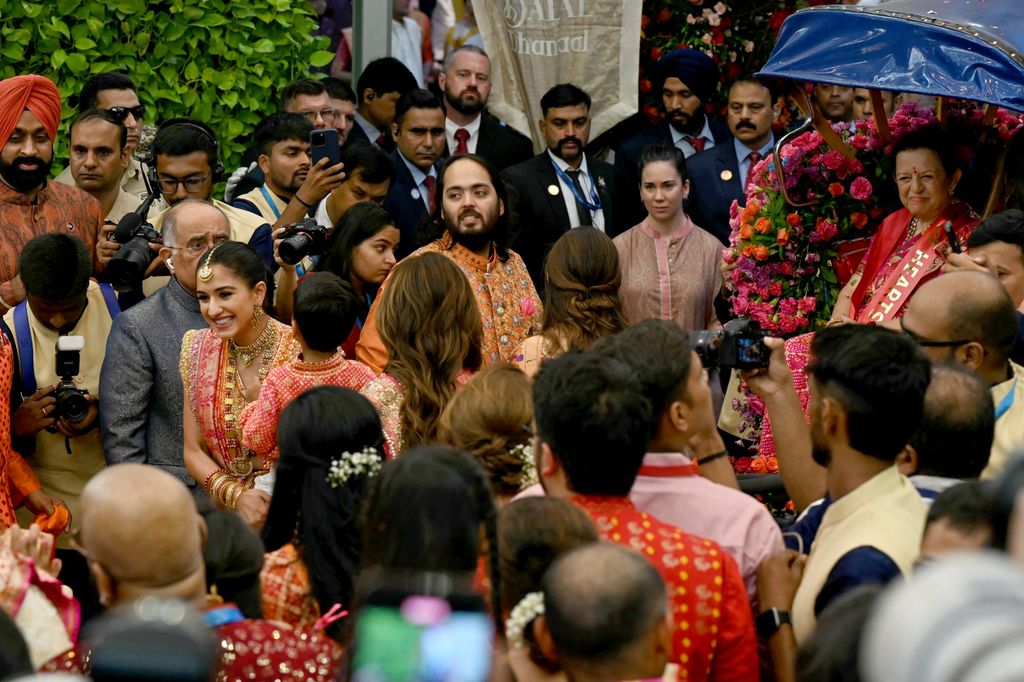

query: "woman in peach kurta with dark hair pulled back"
xmin=614 ymin=144 xmax=722 ymax=331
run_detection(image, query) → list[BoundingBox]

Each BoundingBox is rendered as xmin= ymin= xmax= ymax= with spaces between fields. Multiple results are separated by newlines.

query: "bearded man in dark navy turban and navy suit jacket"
xmin=615 ymin=48 xmax=732 ymax=225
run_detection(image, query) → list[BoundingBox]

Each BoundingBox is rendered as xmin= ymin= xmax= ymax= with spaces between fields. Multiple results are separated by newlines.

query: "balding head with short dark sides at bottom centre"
xmin=543 ymin=543 xmax=668 ymax=680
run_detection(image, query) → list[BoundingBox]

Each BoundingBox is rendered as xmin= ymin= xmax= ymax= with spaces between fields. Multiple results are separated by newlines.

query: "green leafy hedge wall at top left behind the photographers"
xmin=0 ymin=0 xmax=333 ymax=172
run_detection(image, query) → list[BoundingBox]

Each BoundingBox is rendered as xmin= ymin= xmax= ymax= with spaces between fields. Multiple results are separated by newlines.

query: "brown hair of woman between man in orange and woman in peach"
xmin=541 ymin=227 xmax=626 ymax=355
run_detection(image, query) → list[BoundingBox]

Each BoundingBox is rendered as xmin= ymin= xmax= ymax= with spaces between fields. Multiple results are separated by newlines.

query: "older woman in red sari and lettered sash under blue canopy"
xmin=833 ymin=128 xmax=979 ymax=328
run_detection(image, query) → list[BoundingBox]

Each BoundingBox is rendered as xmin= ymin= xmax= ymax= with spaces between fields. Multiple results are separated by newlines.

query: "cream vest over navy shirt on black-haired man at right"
xmin=793 ymin=465 xmax=928 ymax=643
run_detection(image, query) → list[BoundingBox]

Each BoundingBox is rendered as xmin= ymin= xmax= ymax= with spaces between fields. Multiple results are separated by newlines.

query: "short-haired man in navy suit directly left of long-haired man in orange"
xmin=384 ymin=90 xmax=444 ymax=258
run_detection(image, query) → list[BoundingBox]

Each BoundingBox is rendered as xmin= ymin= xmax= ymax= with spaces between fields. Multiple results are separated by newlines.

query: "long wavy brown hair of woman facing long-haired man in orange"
xmin=377 ymin=253 xmax=483 ymax=447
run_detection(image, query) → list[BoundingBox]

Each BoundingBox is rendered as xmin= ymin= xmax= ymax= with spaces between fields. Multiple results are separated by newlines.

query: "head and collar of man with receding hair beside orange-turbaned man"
xmin=69 ymin=109 xmax=138 ymax=225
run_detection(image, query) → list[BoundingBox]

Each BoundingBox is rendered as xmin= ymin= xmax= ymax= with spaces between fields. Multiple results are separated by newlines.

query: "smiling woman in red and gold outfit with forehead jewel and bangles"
xmin=181 ymin=242 xmax=299 ymax=527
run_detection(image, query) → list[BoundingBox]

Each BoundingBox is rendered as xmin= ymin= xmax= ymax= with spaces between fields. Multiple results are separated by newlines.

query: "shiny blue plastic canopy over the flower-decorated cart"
xmin=759 ymin=0 xmax=1024 ymax=112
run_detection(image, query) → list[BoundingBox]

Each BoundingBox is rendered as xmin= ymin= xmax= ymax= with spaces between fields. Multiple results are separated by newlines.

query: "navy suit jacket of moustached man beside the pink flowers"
xmin=686 ymin=139 xmax=743 ymax=244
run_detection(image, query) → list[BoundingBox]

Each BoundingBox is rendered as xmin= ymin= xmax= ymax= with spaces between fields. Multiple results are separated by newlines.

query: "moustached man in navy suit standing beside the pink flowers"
xmin=686 ymin=76 xmax=779 ymax=244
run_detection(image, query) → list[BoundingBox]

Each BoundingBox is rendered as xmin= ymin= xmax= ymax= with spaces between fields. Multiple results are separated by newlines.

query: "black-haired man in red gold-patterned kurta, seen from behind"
xmin=534 ymin=352 xmax=759 ymax=681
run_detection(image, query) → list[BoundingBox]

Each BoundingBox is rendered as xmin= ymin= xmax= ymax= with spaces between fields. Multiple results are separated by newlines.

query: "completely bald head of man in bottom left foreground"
xmin=80 ymin=464 xmax=205 ymax=598
